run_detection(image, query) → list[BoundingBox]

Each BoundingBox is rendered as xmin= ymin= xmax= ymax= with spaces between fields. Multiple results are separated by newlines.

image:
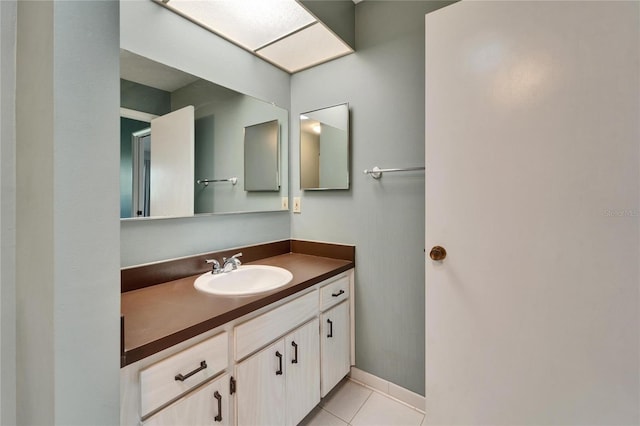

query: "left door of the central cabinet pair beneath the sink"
xmin=236 ymin=339 xmax=286 ymax=426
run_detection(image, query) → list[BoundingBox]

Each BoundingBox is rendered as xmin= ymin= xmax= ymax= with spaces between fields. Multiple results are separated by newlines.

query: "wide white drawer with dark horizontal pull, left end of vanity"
xmin=140 ymin=333 xmax=229 ymax=417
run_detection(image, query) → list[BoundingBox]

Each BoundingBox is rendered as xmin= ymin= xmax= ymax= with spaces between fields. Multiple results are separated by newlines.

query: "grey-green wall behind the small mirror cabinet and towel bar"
xmin=291 ymin=1 xmax=450 ymax=395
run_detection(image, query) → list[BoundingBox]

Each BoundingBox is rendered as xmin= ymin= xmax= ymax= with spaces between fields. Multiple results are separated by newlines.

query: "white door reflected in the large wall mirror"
xmin=150 ymin=105 xmax=195 ymax=216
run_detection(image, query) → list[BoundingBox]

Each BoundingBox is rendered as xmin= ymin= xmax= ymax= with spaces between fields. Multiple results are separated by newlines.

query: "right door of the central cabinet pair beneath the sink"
xmin=285 ymin=318 xmax=320 ymax=426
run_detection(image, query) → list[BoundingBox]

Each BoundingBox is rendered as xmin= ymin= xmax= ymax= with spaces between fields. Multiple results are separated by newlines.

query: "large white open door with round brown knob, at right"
xmin=426 ymin=1 xmax=640 ymax=425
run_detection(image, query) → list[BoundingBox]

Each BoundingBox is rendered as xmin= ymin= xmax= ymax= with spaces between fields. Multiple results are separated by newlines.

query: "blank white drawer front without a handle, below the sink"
xmin=234 ymin=290 xmax=318 ymax=360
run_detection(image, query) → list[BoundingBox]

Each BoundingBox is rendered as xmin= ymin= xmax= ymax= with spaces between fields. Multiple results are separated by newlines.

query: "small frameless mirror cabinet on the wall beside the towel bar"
xmin=300 ymin=103 xmax=349 ymax=190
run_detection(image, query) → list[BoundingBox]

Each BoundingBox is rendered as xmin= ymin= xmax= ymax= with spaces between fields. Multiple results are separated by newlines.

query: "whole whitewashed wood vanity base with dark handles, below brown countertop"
xmin=121 ymin=270 xmax=353 ymax=426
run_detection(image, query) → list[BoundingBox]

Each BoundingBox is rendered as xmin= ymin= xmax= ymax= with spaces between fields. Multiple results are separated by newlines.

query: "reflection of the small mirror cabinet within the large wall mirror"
xmin=244 ymin=120 xmax=280 ymax=191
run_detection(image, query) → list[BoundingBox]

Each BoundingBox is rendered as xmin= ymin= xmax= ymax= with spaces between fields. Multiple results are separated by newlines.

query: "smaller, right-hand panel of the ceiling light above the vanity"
xmin=256 ymin=23 xmax=353 ymax=73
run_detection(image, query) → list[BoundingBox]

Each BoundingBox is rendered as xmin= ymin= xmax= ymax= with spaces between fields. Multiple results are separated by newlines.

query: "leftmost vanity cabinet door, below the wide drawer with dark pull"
xmin=142 ymin=374 xmax=231 ymax=426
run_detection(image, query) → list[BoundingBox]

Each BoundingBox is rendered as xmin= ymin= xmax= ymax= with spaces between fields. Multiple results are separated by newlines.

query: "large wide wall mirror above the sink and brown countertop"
xmin=120 ymin=50 xmax=289 ymax=218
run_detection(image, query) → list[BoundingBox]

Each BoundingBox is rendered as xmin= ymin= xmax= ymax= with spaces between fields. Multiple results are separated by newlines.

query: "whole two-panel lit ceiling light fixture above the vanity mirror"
xmin=154 ymin=0 xmax=353 ymax=73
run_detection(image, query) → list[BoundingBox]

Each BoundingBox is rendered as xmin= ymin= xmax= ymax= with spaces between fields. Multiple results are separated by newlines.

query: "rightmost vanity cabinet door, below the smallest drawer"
xmin=320 ymin=302 xmax=351 ymax=398
